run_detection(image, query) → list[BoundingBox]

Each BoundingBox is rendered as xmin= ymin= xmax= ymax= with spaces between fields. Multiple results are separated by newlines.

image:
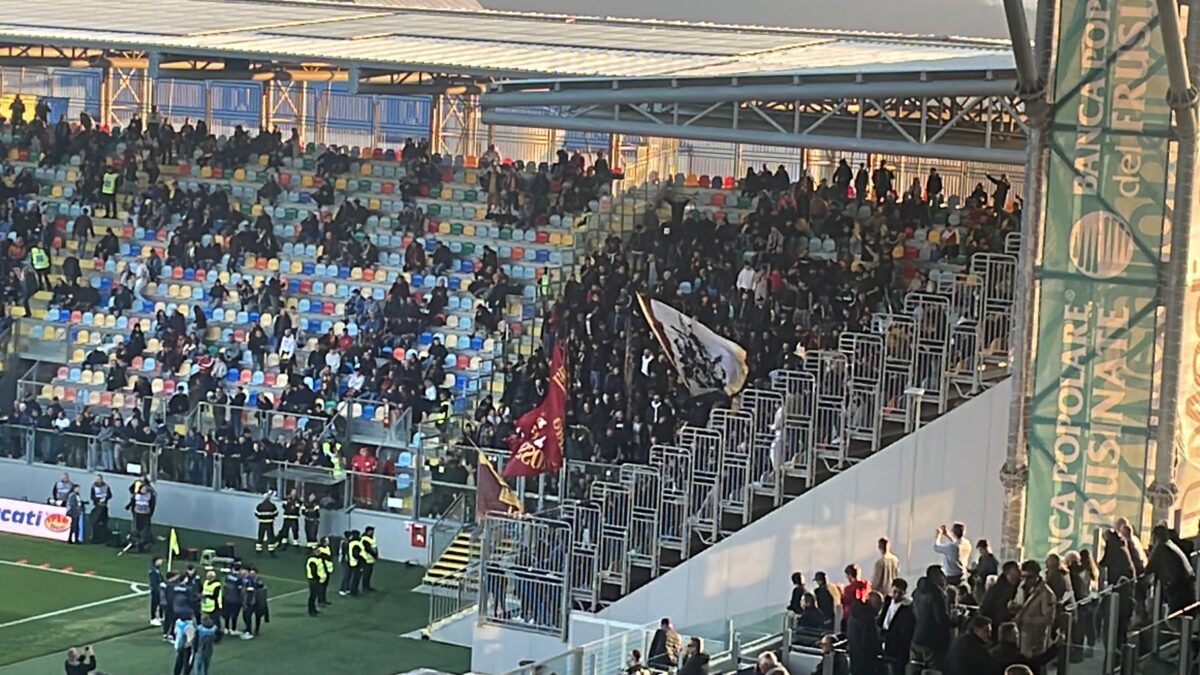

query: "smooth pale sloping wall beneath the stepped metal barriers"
xmin=472 ymin=380 xmax=1012 ymax=673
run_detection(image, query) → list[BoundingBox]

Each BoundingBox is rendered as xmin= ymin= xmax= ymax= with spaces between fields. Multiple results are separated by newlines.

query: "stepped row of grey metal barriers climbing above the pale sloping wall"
xmin=480 ymin=241 xmax=1016 ymax=634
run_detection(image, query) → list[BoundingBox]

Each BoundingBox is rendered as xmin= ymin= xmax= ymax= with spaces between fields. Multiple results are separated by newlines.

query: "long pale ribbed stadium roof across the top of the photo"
xmin=0 ymin=0 xmax=1013 ymax=78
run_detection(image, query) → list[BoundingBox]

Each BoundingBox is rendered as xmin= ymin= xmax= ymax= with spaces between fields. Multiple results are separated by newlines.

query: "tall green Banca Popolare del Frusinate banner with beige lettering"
xmin=1025 ymin=0 xmax=1171 ymax=558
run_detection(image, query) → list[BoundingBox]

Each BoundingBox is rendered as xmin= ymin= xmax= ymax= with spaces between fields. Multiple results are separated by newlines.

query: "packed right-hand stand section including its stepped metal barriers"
xmin=475 ymin=159 xmax=1020 ymax=634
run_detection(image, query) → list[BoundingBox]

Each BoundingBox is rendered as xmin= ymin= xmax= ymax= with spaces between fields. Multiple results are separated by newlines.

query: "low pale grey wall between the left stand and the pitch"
xmin=0 ymin=459 xmax=433 ymax=566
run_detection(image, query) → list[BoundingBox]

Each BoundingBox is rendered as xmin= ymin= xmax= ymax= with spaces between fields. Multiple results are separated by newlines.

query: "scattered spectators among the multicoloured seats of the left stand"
xmin=0 ymin=108 xmax=612 ymax=502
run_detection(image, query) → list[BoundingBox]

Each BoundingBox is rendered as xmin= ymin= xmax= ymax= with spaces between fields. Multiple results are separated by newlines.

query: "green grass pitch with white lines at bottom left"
xmin=0 ymin=527 xmax=470 ymax=675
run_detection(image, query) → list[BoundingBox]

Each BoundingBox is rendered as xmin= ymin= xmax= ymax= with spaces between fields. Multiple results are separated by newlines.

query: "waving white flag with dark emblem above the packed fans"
xmin=637 ymin=294 xmax=750 ymax=396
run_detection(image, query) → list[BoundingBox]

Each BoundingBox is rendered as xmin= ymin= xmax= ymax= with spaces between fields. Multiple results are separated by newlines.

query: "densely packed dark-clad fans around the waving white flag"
xmin=473 ymin=156 xmax=1021 ymax=494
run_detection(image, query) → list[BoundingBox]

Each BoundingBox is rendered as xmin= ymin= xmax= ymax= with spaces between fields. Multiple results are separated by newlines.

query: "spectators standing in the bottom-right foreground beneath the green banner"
xmin=629 ymin=519 xmax=1196 ymax=675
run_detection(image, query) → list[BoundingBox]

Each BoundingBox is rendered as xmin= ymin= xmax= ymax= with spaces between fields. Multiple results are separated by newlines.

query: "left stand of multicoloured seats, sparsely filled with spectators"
xmin=4 ymin=110 xmax=610 ymax=508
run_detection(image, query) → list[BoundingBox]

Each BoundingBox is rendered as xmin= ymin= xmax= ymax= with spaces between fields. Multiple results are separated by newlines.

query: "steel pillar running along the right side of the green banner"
xmin=1147 ymin=0 xmax=1200 ymax=522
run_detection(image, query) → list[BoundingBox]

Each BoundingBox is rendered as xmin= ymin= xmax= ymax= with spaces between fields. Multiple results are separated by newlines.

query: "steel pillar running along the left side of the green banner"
xmin=1000 ymin=0 xmax=1057 ymax=560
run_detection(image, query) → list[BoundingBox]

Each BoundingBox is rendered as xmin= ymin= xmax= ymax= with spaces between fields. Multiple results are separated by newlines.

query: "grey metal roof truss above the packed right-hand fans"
xmin=481 ymin=73 xmax=1027 ymax=165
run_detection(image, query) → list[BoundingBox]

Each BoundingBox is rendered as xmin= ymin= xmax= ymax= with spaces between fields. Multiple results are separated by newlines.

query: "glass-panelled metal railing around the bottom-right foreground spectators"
xmin=504 ymin=556 xmax=1200 ymax=675
